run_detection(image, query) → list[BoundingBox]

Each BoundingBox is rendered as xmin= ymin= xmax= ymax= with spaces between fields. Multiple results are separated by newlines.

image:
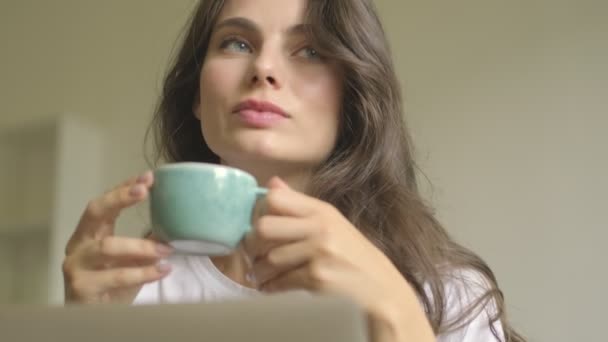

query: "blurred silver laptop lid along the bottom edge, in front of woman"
xmin=0 ymin=295 xmax=367 ymax=342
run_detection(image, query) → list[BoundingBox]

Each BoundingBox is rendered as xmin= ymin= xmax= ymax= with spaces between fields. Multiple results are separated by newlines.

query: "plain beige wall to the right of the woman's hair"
xmin=379 ymin=0 xmax=608 ymax=341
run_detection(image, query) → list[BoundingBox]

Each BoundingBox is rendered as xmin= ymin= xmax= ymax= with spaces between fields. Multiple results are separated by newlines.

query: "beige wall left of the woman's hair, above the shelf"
xmin=0 ymin=0 xmax=193 ymax=235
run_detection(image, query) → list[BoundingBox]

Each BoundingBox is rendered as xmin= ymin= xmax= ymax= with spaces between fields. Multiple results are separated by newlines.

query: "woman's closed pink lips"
xmin=232 ymin=99 xmax=289 ymax=128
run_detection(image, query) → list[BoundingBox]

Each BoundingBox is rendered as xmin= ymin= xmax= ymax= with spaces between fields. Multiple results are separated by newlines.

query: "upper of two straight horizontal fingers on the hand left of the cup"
xmin=84 ymin=236 xmax=173 ymax=267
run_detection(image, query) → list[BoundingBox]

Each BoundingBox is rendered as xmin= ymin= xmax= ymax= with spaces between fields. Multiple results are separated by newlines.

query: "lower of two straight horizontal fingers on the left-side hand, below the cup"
xmin=90 ymin=262 xmax=171 ymax=292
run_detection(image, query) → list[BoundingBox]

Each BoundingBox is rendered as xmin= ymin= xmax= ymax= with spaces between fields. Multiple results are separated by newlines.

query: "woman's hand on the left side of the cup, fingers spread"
xmin=63 ymin=171 xmax=172 ymax=303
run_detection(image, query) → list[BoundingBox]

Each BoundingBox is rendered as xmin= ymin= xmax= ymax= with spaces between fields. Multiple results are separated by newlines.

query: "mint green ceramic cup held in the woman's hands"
xmin=150 ymin=162 xmax=267 ymax=255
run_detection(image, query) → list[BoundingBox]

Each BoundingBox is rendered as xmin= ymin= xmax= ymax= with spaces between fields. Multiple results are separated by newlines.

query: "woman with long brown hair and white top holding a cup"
xmin=64 ymin=0 xmax=523 ymax=341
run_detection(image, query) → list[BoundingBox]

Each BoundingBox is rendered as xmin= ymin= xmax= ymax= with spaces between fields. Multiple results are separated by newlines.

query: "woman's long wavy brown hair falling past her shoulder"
xmin=147 ymin=0 xmax=524 ymax=342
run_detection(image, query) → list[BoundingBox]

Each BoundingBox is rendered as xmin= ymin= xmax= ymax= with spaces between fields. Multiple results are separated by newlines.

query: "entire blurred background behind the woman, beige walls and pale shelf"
xmin=0 ymin=0 xmax=608 ymax=341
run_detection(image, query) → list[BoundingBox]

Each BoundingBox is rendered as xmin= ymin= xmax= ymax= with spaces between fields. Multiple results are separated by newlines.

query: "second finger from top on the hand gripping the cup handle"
xmin=242 ymin=215 xmax=313 ymax=260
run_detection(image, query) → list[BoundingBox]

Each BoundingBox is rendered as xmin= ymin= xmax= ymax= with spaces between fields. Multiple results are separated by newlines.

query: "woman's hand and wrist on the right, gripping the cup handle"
xmin=243 ymin=178 xmax=433 ymax=341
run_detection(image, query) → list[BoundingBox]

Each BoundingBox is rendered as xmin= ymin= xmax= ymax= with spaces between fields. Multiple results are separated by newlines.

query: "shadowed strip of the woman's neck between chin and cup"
xmin=221 ymin=160 xmax=312 ymax=193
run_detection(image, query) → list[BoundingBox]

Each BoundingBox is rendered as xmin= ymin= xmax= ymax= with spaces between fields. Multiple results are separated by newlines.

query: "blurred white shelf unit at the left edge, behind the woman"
xmin=0 ymin=116 xmax=102 ymax=305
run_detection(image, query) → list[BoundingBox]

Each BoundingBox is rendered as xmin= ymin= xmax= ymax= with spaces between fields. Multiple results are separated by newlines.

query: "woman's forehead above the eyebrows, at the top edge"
xmin=217 ymin=0 xmax=308 ymax=30
